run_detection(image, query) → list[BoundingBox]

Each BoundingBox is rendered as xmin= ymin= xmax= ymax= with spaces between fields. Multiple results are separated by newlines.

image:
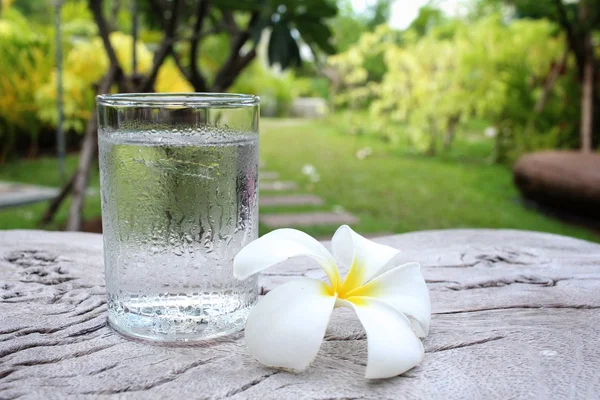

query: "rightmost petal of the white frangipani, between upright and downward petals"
xmin=347 ymin=263 xmax=431 ymax=337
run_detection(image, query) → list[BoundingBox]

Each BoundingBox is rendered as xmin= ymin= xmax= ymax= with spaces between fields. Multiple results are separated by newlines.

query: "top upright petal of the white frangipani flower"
xmin=331 ymin=225 xmax=400 ymax=290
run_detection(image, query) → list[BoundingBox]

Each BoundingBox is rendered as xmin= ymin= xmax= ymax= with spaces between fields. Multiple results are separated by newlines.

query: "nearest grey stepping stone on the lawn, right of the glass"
xmin=260 ymin=211 xmax=358 ymax=228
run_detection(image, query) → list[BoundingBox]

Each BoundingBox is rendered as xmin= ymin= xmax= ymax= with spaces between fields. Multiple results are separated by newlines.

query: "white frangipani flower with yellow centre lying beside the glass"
xmin=233 ymin=225 xmax=431 ymax=379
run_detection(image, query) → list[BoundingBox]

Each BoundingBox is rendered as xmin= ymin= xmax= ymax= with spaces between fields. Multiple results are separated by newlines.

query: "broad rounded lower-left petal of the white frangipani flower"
xmin=246 ymin=278 xmax=336 ymax=371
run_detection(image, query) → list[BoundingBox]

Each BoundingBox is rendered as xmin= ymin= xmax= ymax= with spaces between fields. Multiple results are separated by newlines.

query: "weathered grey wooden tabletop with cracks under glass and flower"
xmin=0 ymin=230 xmax=600 ymax=400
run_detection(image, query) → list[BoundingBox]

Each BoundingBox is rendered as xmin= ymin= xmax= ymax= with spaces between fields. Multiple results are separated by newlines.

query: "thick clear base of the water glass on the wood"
xmin=108 ymin=307 xmax=251 ymax=343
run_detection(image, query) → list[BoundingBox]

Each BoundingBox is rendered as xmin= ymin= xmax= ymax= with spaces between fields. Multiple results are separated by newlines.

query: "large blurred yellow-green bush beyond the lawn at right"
xmin=330 ymin=15 xmax=577 ymax=161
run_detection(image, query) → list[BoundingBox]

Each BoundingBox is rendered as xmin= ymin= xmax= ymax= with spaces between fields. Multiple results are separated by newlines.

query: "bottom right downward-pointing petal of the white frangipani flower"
xmin=338 ymin=299 xmax=424 ymax=379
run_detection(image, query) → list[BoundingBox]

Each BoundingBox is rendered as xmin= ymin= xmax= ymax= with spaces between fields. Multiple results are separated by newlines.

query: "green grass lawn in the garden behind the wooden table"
xmin=0 ymin=115 xmax=600 ymax=241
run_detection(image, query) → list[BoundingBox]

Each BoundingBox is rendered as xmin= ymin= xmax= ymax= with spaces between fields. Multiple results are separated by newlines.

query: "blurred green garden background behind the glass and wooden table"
xmin=0 ymin=0 xmax=600 ymax=241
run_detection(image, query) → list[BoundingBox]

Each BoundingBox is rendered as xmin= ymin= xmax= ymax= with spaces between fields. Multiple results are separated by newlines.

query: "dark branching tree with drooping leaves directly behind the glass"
xmin=43 ymin=0 xmax=337 ymax=231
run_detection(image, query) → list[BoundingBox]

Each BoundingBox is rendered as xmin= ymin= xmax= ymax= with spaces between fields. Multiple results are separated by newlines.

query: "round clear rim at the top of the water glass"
xmin=96 ymin=92 xmax=260 ymax=108
